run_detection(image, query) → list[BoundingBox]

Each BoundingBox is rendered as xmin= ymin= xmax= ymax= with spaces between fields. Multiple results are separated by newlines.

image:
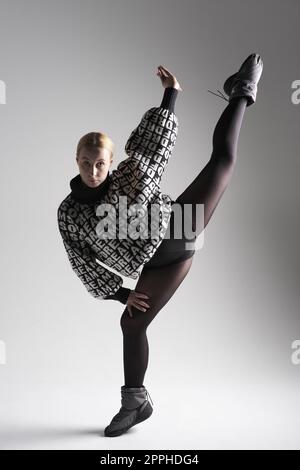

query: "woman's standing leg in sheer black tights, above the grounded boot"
xmin=120 ymin=257 xmax=193 ymax=387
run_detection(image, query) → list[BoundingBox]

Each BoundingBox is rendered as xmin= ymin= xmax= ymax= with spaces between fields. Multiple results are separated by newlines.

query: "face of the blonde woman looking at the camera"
xmin=76 ymin=147 xmax=113 ymax=188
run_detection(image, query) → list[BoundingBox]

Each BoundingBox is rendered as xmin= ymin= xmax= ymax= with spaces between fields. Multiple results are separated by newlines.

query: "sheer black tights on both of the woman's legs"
xmin=120 ymin=98 xmax=246 ymax=387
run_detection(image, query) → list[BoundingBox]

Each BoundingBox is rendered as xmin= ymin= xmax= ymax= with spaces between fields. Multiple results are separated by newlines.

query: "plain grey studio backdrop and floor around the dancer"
xmin=0 ymin=0 xmax=300 ymax=449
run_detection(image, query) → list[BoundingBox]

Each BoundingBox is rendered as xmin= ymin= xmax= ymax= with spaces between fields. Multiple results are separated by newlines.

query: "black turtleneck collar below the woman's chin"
xmin=70 ymin=172 xmax=110 ymax=204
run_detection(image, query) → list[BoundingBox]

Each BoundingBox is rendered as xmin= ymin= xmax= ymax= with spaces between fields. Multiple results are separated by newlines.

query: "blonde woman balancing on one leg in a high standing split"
xmin=58 ymin=54 xmax=263 ymax=436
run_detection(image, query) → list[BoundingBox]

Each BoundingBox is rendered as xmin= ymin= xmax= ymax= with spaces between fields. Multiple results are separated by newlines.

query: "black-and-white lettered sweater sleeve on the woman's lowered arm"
xmin=58 ymin=211 xmax=123 ymax=299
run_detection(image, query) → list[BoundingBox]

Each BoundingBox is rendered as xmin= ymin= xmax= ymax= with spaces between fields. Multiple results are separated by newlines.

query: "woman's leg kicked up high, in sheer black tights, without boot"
xmin=176 ymin=97 xmax=247 ymax=235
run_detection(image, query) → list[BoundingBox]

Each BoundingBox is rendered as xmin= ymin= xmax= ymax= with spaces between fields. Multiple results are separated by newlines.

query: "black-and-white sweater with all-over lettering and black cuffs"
xmin=57 ymin=87 xmax=178 ymax=304
